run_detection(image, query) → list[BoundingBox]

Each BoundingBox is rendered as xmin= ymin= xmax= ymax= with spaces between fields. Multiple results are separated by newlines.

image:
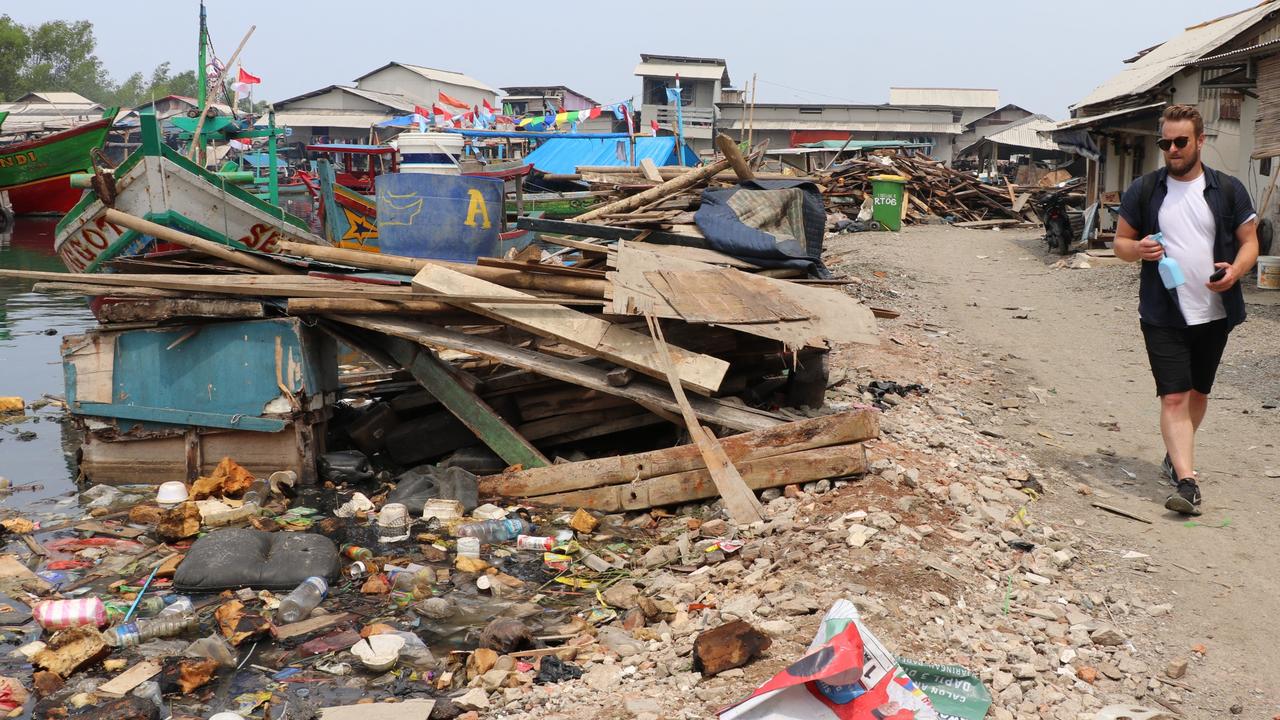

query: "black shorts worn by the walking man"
xmin=1142 ymin=318 xmax=1231 ymax=396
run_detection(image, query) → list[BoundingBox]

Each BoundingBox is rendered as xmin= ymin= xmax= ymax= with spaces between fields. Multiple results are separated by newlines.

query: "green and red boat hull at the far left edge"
xmin=0 ymin=108 xmax=116 ymax=215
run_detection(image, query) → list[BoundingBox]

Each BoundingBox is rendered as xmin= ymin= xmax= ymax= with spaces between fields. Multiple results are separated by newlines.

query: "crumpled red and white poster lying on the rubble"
xmin=719 ymin=600 xmax=940 ymax=720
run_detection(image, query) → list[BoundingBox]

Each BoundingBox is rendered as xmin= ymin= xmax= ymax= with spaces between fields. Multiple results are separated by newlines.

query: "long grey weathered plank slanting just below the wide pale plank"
xmin=330 ymin=315 xmax=782 ymax=430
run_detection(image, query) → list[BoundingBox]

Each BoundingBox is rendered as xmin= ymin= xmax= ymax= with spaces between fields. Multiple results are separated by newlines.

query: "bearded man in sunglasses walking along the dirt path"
xmin=1115 ymin=105 xmax=1254 ymax=515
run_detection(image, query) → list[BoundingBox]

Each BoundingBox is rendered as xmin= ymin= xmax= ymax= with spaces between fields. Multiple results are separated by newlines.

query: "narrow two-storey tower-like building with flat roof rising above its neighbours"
xmin=635 ymin=54 xmax=730 ymax=152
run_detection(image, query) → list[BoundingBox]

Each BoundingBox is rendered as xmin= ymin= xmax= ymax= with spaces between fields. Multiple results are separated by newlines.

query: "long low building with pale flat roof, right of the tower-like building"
xmin=717 ymin=102 xmax=964 ymax=163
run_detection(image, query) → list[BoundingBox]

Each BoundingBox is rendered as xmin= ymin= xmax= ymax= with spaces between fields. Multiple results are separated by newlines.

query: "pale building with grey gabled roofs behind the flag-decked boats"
xmin=275 ymin=63 xmax=498 ymax=143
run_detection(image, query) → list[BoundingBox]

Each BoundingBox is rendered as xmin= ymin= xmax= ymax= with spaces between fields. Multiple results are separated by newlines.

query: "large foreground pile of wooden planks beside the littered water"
xmin=15 ymin=192 xmax=877 ymax=521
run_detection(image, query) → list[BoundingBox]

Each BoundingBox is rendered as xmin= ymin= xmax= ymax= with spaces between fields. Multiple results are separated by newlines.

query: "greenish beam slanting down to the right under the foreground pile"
xmin=373 ymin=338 xmax=550 ymax=468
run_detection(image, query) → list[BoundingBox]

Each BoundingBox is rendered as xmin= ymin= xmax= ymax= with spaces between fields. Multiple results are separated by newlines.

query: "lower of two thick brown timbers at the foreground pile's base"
xmin=529 ymin=443 xmax=867 ymax=512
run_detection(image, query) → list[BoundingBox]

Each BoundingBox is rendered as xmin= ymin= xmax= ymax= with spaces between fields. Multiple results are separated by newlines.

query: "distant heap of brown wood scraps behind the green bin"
xmin=818 ymin=151 xmax=1055 ymax=227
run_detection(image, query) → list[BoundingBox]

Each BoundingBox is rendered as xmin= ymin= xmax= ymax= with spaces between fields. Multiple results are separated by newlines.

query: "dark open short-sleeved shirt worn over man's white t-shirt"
xmin=1120 ymin=165 xmax=1254 ymax=328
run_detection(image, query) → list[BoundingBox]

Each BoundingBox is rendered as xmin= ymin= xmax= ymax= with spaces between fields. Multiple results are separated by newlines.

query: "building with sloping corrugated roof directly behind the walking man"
xmin=1052 ymin=0 xmax=1280 ymax=210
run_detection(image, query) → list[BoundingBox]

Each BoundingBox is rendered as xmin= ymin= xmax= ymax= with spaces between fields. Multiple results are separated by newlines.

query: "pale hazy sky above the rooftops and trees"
xmin=0 ymin=0 xmax=1251 ymax=118
